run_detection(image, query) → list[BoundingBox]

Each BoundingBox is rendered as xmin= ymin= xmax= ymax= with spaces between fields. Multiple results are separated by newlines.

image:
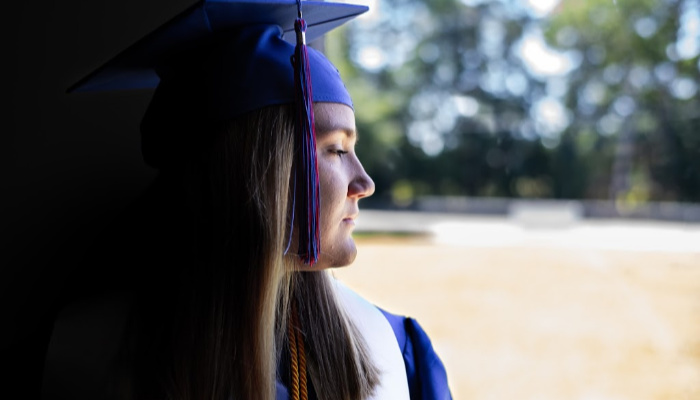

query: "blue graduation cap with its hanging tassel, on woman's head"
xmin=68 ymin=0 xmax=368 ymax=265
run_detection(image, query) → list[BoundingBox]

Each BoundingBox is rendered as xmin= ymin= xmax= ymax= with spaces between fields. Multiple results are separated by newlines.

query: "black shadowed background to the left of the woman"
xmin=0 ymin=0 xmax=193 ymax=399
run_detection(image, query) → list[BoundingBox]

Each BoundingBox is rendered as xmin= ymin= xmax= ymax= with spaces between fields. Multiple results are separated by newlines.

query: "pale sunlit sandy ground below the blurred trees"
xmin=335 ymin=212 xmax=700 ymax=400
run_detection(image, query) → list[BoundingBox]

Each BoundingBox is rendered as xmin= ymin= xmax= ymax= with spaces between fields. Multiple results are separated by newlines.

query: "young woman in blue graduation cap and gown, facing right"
xmin=44 ymin=0 xmax=450 ymax=399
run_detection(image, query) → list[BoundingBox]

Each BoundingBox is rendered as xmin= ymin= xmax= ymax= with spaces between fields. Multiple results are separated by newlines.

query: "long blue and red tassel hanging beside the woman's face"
xmin=292 ymin=0 xmax=321 ymax=266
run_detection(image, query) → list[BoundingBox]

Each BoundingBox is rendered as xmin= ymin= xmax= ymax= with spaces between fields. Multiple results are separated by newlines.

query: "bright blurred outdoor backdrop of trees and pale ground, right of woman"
xmin=326 ymin=0 xmax=700 ymax=400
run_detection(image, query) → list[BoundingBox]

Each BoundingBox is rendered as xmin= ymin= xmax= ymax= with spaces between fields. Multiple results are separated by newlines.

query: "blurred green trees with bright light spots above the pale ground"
xmin=328 ymin=0 xmax=700 ymax=205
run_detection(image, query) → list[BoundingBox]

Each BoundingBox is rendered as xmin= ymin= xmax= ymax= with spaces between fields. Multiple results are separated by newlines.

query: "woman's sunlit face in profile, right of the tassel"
xmin=314 ymin=103 xmax=374 ymax=269
